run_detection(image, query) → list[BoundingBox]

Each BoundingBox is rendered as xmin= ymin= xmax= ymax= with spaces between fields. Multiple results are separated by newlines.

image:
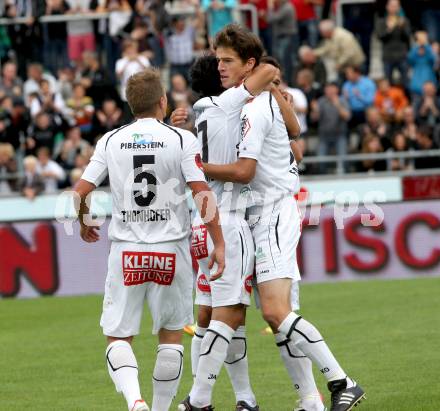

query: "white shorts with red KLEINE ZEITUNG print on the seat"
xmin=101 ymin=238 xmax=194 ymax=338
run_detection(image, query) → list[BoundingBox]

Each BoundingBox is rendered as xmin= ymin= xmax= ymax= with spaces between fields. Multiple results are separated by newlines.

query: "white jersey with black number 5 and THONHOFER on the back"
xmin=82 ymin=118 xmax=205 ymax=244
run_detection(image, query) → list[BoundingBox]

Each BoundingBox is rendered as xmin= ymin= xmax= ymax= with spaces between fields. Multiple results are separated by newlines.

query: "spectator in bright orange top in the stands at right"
xmin=374 ymin=78 xmax=409 ymax=123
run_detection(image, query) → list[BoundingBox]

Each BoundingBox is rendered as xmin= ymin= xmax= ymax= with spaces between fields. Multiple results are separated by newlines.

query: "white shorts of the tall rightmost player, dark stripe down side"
xmin=248 ymin=195 xmax=301 ymax=283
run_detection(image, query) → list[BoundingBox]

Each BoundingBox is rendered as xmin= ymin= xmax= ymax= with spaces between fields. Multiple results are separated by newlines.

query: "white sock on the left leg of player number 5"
xmin=105 ymin=340 xmax=142 ymax=410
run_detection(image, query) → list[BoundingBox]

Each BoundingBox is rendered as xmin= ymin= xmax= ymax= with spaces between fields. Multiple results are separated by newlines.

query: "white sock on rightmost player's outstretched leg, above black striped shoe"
xmin=278 ymin=312 xmax=346 ymax=381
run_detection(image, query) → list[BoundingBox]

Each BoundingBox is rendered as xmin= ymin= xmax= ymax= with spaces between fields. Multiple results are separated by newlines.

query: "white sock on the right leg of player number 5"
xmin=151 ymin=344 xmax=183 ymax=411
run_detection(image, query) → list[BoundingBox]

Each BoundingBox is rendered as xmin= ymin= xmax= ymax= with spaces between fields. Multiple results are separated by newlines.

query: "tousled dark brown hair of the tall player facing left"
xmin=214 ymin=24 xmax=264 ymax=65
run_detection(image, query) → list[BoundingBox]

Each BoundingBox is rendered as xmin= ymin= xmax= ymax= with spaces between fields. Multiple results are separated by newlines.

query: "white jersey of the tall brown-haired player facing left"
xmin=239 ymin=91 xmax=299 ymax=205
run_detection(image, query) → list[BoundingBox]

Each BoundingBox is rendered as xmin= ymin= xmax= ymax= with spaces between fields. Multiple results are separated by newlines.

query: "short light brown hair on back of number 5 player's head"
xmin=126 ymin=68 xmax=165 ymax=117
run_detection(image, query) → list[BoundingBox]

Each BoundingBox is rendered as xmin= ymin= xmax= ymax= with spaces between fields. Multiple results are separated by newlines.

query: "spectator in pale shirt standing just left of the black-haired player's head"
xmin=165 ymin=16 xmax=195 ymax=82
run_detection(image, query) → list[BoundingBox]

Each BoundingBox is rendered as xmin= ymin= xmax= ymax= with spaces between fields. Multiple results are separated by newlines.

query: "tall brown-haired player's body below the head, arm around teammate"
xmin=205 ymin=57 xmax=364 ymax=411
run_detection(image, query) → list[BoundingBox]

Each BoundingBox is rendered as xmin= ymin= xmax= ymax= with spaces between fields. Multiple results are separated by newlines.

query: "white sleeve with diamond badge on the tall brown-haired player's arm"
xmin=238 ymin=103 xmax=272 ymax=161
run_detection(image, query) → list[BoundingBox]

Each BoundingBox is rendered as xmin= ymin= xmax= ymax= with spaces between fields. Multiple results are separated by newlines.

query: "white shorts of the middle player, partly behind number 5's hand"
xmin=191 ymin=213 xmax=254 ymax=307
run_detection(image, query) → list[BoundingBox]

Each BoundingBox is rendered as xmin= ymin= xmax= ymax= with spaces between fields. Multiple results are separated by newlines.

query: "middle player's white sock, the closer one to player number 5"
xmin=190 ymin=320 xmax=234 ymax=408
